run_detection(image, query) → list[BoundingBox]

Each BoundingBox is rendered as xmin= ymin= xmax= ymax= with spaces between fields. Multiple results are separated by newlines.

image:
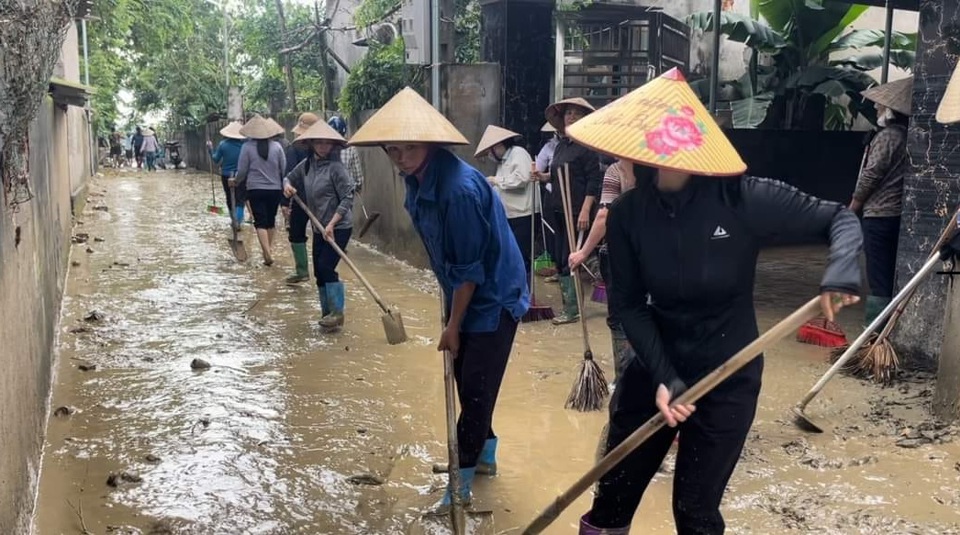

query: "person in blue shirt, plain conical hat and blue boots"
xmin=350 ymin=88 xmax=529 ymax=505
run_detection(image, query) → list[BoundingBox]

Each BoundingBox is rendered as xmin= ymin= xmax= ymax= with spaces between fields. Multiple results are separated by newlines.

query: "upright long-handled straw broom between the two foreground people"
xmin=557 ymin=165 xmax=610 ymax=412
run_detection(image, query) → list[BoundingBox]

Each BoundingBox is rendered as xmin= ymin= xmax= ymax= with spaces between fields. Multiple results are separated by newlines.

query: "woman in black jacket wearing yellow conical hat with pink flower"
xmin=569 ymin=69 xmax=862 ymax=535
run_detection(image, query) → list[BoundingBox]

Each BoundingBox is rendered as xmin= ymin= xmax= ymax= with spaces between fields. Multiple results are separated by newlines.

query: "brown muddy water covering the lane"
xmin=35 ymin=172 xmax=960 ymax=535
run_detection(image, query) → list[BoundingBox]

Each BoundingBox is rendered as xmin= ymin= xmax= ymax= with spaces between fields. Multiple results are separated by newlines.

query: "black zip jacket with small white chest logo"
xmin=606 ymin=177 xmax=863 ymax=391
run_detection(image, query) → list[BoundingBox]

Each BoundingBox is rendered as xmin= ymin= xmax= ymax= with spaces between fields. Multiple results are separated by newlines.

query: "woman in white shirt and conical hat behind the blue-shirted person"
xmin=474 ymin=125 xmax=536 ymax=284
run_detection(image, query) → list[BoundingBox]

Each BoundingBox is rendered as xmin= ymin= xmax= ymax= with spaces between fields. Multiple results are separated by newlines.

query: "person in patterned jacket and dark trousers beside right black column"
xmin=850 ymin=76 xmax=913 ymax=324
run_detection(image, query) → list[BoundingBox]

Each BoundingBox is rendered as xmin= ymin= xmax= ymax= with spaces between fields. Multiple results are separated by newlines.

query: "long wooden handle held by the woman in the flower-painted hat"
xmin=523 ymin=296 xmax=820 ymax=535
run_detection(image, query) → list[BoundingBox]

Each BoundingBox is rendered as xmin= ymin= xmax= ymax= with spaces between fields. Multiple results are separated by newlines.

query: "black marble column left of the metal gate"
xmin=481 ymin=0 xmax=554 ymax=154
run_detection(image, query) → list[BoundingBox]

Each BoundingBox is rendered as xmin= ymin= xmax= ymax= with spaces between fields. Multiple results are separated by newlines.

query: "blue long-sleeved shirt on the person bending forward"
xmin=404 ymin=149 xmax=530 ymax=332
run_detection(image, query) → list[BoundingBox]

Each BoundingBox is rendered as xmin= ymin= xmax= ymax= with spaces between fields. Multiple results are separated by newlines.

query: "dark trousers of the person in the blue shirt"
xmin=453 ymin=310 xmax=517 ymax=468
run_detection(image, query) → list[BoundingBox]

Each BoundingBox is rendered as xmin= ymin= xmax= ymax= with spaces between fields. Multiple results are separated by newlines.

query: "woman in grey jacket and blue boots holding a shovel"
xmin=283 ymin=121 xmax=353 ymax=332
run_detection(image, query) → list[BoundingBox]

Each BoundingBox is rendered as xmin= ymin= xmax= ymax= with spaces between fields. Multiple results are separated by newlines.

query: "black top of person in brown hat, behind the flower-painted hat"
xmin=545 ymin=137 xmax=603 ymax=220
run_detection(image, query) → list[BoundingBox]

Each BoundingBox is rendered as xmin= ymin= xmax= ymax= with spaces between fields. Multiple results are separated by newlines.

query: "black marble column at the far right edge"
xmin=894 ymin=0 xmax=960 ymax=365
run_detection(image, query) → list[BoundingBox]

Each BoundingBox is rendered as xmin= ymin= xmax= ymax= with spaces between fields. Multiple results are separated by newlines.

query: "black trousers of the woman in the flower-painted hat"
xmin=589 ymin=357 xmax=763 ymax=535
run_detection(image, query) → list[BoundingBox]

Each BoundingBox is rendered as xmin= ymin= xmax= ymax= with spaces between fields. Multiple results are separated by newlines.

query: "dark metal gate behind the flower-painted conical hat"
xmin=557 ymin=4 xmax=690 ymax=107
